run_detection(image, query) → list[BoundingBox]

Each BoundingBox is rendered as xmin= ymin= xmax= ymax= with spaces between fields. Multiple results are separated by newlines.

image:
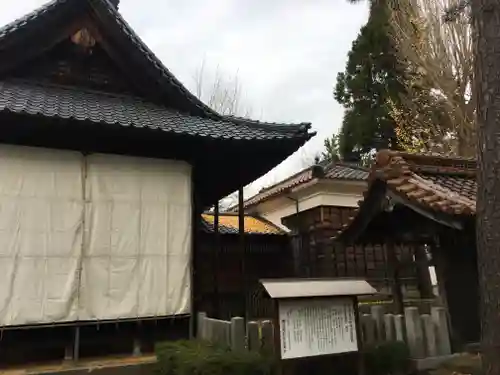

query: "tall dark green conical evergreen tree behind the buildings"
xmin=334 ymin=0 xmax=404 ymax=159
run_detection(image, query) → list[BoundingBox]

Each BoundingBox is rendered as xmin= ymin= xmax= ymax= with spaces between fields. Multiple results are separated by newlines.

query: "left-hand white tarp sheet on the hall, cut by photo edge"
xmin=0 ymin=145 xmax=83 ymax=326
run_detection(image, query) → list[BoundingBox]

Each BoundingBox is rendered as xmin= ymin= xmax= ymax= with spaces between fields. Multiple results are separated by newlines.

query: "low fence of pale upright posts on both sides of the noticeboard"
xmin=197 ymin=306 xmax=451 ymax=359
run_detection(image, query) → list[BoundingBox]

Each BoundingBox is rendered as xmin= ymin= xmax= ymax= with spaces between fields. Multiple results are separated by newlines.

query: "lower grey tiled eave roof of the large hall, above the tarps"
xmin=0 ymin=81 xmax=304 ymax=139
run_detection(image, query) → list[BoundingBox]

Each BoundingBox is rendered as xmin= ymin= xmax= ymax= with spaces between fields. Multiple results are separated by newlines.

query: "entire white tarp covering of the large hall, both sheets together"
xmin=0 ymin=145 xmax=191 ymax=326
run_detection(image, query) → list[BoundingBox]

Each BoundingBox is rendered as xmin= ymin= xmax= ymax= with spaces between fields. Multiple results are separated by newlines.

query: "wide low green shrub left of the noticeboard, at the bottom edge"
xmin=156 ymin=340 xmax=273 ymax=375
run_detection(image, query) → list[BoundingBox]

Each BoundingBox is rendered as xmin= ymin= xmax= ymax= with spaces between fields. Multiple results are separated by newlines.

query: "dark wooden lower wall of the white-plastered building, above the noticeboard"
xmin=284 ymin=206 xmax=426 ymax=292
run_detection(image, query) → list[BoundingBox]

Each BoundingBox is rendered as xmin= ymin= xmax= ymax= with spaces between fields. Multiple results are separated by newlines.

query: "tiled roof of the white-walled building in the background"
xmin=231 ymin=162 xmax=368 ymax=210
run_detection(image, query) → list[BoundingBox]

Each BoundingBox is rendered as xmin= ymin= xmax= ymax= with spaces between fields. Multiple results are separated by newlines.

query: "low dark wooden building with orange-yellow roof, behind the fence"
xmin=195 ymin=214 xmax=293 ymax=319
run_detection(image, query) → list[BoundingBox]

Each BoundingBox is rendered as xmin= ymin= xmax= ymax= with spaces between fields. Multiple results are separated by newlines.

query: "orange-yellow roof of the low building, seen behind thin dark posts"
xmin=202 ymin=213 xmax=286 ymax=235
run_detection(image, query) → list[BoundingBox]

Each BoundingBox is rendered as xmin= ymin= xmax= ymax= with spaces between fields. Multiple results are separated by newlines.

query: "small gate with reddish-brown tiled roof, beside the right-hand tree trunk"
xmin=336 ymin=150 xmax=480 ymax=350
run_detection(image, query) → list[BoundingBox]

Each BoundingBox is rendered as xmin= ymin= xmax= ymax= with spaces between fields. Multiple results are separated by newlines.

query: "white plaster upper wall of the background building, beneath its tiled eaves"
xmin=252 ymin=180 xmax=366 ymax=229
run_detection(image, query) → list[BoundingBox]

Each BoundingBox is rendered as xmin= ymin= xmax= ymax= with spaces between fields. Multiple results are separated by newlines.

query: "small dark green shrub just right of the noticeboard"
xmin=365 ymin=341 xmax=410 ymax=375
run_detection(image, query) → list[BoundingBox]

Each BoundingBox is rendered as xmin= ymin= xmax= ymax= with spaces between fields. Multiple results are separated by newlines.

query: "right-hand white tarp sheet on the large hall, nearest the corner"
xmin=80 ymin=155 xmax=191 ymax=320
